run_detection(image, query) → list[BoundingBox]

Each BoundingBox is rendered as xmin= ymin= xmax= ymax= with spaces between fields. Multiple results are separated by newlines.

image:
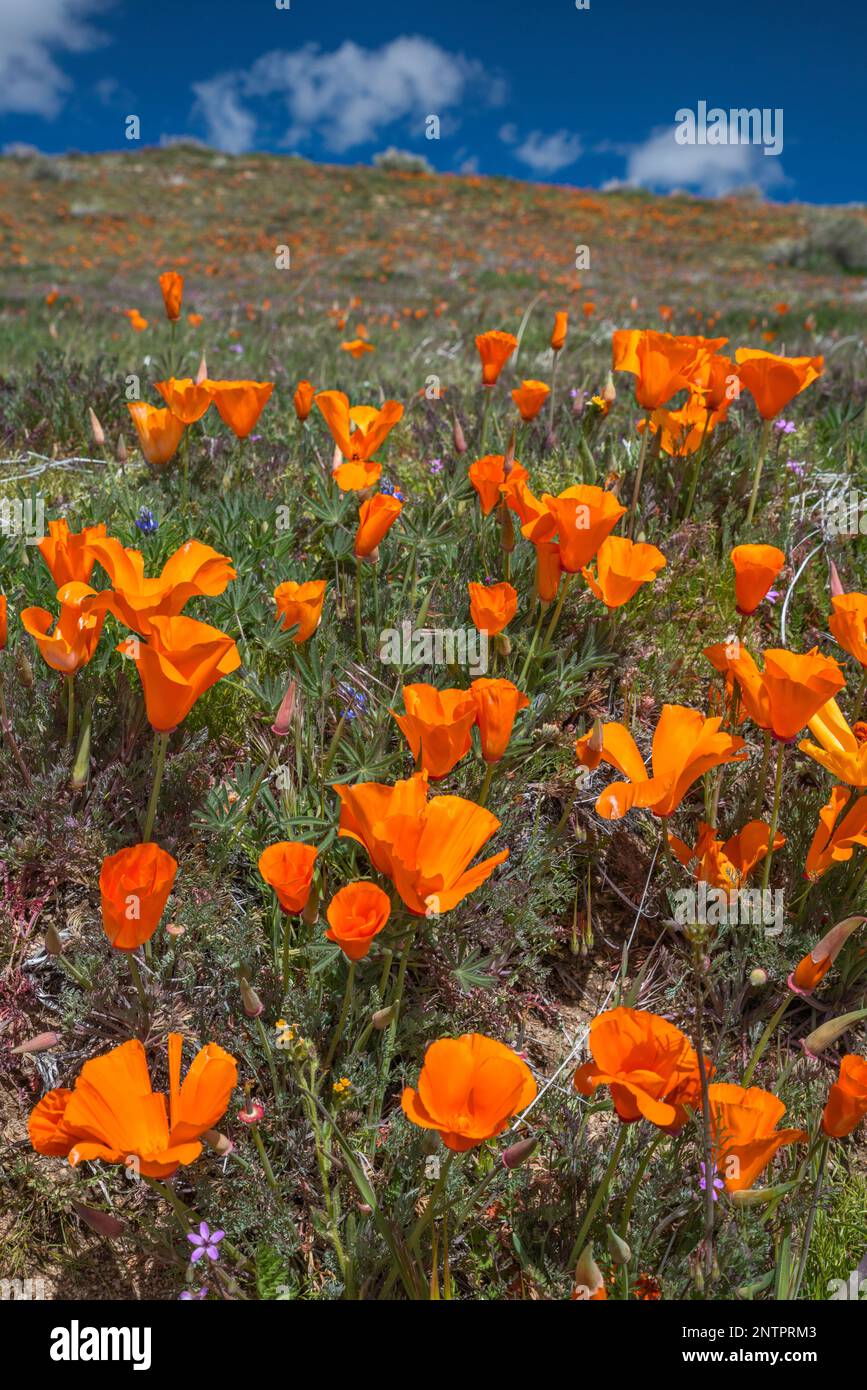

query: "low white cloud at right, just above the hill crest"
xmin=625 ymin=126 xmax=786 ymax=197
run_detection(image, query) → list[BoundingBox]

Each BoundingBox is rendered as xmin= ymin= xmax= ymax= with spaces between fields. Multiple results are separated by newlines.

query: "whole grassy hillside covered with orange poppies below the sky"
xmin=0 ymin=150 xmax=867 ymax=1301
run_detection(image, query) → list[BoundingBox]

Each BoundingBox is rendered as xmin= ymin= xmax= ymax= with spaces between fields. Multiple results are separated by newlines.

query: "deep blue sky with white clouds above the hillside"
xmin=0 ymin=0 xmax=867 ymax=203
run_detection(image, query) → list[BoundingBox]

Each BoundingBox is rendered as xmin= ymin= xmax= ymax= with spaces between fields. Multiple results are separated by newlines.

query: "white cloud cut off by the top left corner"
xmin=0 ymin=0 xmax=111 ymax=120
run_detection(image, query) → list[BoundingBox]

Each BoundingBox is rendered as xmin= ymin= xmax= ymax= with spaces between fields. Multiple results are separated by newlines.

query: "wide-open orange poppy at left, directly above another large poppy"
xmin=85 ymin=537 xmax=238 ymax=637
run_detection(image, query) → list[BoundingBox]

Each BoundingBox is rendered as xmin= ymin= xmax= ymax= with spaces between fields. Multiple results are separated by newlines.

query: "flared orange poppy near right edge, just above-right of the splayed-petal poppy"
xmin=704 ymin=644 xmax=846 ymax=744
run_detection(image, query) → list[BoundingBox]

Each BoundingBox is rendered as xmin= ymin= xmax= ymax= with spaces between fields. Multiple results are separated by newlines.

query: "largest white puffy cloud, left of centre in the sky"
xmin=193 ymin=35 xmax=504 ymax=154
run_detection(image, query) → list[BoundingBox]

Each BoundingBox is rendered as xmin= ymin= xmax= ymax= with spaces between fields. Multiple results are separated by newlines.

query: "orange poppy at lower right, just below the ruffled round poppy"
xmin=709 ymin=1083 xmax=809 ymax=1193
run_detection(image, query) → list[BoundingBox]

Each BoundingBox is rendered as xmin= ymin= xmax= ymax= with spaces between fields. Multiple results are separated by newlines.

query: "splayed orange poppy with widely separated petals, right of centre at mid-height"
xmin=575 ymin=705 xmax=746 ymax=820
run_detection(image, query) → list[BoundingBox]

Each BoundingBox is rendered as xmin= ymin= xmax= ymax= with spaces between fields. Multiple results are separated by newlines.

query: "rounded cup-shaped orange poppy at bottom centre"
xmin=400 ymin=1033 xmax=536 ymax=1154
